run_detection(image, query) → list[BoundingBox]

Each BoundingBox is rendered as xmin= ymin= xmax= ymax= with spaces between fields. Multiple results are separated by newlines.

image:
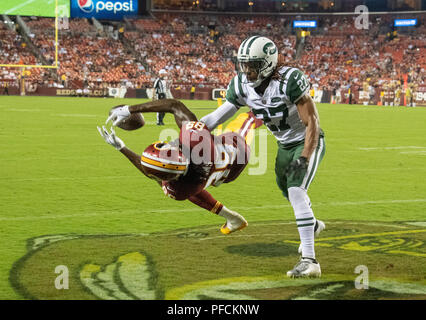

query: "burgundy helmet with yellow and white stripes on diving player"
xmin=141 ymin=141 xmax=189 ymax=181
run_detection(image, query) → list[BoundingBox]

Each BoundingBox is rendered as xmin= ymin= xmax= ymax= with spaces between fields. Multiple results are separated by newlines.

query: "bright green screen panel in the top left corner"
xmin=0 ymin=0 xmax=70 ymax=17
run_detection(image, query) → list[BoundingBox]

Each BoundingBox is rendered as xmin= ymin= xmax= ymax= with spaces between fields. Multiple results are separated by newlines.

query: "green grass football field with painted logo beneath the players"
xmin=0 ymin=97 xmax=426 ymax=299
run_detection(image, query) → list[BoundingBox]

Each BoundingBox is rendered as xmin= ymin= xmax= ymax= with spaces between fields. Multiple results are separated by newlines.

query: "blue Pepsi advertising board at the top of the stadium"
xmin=71 ymin=0 xmax=138 ymax=20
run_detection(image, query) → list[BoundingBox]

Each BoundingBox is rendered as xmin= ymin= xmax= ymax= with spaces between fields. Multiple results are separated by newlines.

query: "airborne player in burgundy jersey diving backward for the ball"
xmin=98 ymin=99 xmax=262 ymax=234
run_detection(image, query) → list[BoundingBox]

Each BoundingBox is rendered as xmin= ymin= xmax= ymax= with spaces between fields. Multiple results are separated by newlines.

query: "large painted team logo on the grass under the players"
xmin=10 ymin=221 xmax=426 ymax=300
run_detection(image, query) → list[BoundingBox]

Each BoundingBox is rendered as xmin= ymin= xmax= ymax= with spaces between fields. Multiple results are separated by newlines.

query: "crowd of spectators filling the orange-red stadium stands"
xmin=0 ymin=13 xmax=426 ymax=97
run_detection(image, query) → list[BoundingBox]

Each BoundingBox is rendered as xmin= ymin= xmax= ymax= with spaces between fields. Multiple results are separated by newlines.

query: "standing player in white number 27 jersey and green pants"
xmin=201 ymin=36 xmax=325 ymax=278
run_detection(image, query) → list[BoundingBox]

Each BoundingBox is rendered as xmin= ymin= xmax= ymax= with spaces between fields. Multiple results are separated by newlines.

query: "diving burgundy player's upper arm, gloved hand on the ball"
xmin=106 ymin=99 xmax=197 ymax=128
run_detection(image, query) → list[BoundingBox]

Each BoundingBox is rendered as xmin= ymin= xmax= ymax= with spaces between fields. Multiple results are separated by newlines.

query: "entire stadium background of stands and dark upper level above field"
xmin=0 ymin=0 xmax=426 ymax=105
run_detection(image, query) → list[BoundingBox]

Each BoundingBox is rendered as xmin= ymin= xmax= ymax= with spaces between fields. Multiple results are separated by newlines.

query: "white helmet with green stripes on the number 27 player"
xmin=237 ymin=36 xmax=278 ymax=88
